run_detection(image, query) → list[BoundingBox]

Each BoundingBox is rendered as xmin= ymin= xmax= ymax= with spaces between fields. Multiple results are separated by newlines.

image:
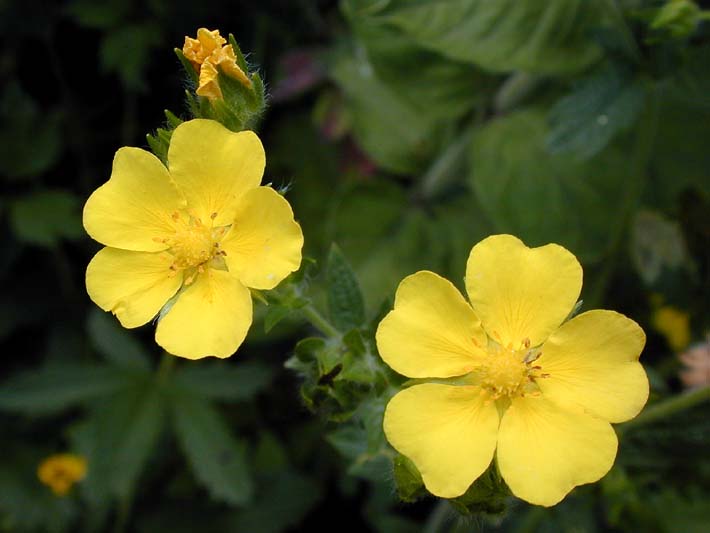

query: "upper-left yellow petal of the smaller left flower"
xmin=84 ymin=148 xmax=185 ymax=252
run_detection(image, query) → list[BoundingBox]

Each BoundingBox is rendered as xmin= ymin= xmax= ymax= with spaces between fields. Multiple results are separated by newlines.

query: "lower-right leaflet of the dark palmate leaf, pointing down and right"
xmin=173 ymin=394 xmax=253 ymax=505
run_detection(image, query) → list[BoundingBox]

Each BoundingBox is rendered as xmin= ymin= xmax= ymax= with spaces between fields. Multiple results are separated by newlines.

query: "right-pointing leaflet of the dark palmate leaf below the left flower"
xmin=173 ymin=361 xmax=274 ymax=402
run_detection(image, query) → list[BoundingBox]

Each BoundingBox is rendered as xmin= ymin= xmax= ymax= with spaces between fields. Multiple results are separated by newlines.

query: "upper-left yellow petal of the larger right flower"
xmin=376 ymin=271 xmax=486 ymax=378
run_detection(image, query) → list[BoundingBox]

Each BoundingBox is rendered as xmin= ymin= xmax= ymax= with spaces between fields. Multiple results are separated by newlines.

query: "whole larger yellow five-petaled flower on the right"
xmin=377 ymin=235 xmax=648 ymax=506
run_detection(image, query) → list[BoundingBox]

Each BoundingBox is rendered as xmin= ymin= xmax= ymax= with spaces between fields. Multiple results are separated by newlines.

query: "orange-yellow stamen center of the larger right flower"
xmin=481 ymin=341 xmax=548 ymax=400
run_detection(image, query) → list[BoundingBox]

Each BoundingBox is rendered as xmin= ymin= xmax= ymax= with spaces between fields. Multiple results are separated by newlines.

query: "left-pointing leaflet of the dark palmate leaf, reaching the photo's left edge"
xmin=0 ymin=363 xmax=132 ymax=415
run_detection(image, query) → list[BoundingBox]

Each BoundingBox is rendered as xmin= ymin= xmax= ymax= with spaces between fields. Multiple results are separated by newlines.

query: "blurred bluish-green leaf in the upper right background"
xmin=547 ymin=66 xmax=645 ymax=159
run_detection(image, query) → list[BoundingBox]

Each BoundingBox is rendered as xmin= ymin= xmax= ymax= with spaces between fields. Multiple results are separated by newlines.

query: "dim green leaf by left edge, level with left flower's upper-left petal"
xmin=10 ymin=190 xmax=84 ymax=248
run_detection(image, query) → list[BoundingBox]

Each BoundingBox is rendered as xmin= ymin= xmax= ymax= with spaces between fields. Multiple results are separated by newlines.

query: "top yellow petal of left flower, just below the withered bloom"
xmin=168 ymin=119 xmax=266 ymax=226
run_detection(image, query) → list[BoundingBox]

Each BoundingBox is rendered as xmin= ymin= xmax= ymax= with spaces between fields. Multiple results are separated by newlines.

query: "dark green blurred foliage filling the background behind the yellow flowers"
xmin=0 ymin=0 xmax=710 ymax=533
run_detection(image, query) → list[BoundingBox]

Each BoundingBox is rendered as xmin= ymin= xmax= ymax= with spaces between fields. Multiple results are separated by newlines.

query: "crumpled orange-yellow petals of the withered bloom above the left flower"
xmin=182 ymin=28 xmax=252 ymax=101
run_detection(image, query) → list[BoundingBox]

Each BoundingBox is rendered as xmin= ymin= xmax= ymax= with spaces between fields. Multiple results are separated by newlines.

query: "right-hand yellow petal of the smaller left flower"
xmin=220 ymin=187 xmax=303 ymax=290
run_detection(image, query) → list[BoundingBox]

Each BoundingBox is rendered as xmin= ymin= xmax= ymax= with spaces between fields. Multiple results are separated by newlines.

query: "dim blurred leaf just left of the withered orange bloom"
xmin=99 ymin=24 xmax=163 ymax=91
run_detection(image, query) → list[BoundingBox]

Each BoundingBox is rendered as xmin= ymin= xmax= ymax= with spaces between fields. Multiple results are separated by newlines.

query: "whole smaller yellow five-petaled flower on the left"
xmin=84 ymin=119 xmax=303 ymax=359
